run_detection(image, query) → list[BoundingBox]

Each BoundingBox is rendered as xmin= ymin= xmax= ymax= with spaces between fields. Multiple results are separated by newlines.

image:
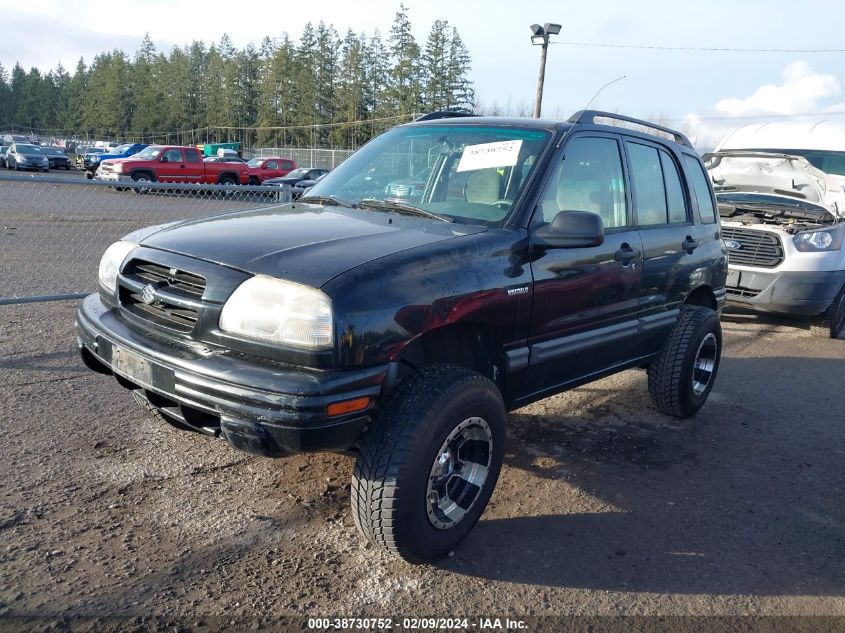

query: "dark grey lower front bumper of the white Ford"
xmin=727 ymin=266 xmax=845 ymax=316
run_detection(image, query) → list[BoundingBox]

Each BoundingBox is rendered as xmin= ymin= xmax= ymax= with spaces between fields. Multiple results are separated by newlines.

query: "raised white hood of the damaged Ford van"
xmin=703 ymin=150 xmax=845 ymax=217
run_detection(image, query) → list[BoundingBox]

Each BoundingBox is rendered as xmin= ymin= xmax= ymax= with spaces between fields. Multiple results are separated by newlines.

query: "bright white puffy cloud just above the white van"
xmin=684 ymin=60 xmax=845 ymax=150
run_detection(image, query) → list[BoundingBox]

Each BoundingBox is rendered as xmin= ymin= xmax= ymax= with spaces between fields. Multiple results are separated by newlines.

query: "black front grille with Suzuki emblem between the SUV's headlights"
xmin=120 ymin=260 xmax=205 ymax=332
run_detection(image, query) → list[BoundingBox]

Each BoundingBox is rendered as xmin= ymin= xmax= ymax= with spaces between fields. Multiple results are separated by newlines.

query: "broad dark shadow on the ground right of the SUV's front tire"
xmin=442 ymin=357 xmax=845 ymax=596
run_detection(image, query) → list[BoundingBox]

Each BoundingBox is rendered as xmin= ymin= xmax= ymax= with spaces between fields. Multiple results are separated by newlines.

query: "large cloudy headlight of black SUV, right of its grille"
xmin=220 ymin=275 xmax=334 ymax=349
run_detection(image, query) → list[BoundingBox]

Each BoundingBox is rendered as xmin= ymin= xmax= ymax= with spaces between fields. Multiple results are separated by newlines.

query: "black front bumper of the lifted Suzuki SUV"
xmin=76 ymin=294 xmax=388 ymax=457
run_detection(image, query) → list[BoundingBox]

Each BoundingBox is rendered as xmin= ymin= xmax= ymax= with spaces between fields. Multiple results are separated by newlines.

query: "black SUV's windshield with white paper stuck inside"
xmin=304 ymin=125 xmax=552 ymax=224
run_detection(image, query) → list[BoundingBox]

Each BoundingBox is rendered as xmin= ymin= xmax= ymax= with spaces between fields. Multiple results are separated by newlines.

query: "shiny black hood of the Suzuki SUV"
xmin=136 ymin=203 xmax=486 ymax=287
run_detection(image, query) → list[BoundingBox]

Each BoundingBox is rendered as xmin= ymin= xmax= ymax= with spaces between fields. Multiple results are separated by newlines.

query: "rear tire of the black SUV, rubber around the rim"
xmin=648 ymin=305 xmax=722 ymax=418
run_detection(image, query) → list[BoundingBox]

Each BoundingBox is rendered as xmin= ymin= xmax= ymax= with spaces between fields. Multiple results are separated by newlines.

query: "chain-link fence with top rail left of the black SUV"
xmin=0 ymin=174 xmax=290 ymax=304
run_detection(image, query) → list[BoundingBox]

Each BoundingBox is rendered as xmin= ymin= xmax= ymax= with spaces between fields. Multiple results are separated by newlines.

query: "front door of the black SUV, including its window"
xmin=525 ymin=132 xmax=642 ymax=394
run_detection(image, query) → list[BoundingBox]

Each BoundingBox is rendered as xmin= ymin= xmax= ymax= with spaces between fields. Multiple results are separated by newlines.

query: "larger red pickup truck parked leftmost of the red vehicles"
xmin=94 ymin=145 xmax=249 ymax=185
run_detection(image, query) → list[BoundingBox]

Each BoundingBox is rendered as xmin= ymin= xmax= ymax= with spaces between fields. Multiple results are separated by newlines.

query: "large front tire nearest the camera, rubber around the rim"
xmin=352 ymin=365 xmax=505 ymax=563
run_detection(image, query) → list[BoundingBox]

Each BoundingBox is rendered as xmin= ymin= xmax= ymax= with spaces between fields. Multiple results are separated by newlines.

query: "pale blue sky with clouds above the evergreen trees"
xmin=0 ymin=0 xmax=845 ymax=148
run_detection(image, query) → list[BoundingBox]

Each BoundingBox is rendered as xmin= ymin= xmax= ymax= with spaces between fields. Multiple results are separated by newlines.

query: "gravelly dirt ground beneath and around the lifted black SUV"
xmin=0 ymin=302 xmax=845 ymax=631
